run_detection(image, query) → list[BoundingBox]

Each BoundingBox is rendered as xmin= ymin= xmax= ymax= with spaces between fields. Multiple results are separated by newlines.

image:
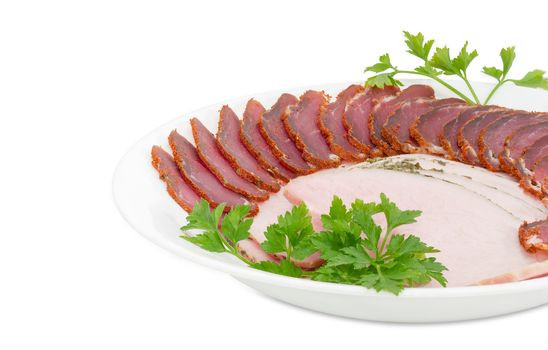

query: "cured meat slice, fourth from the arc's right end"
xmin=478 ymin=112 xmax=548 ymax=171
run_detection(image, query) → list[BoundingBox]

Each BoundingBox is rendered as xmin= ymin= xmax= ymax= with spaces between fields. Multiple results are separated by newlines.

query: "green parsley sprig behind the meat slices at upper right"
xmin=365 ymin=31 xmax=548 ymax=104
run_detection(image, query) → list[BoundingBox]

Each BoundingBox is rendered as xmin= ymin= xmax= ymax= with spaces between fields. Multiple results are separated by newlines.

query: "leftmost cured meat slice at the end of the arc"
xmin=151 ymin=146 xmax=200 ymax=212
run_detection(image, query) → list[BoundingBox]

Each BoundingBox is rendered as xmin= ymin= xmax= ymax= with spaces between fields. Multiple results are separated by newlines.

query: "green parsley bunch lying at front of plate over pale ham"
xmin=181 ymin=194 xmax=447 ymax=295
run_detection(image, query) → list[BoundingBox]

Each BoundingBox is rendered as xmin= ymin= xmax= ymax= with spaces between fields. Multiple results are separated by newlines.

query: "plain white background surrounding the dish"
xmin=0 ymin=0 xmax=548 ymax=350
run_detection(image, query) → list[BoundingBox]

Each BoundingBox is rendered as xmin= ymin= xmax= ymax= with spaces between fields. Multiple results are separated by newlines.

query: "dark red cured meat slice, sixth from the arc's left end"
xmin=259 ymin=94 xmax=315 ymax=175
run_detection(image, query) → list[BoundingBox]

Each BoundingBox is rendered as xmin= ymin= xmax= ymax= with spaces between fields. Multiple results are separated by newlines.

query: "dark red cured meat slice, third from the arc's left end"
xmin=190 ymin=118 xmax=268 ymax=202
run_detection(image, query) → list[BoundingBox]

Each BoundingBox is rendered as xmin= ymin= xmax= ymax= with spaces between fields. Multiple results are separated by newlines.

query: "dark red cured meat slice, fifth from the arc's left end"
xmin=240 ymin=99 xmax=297 ymax=182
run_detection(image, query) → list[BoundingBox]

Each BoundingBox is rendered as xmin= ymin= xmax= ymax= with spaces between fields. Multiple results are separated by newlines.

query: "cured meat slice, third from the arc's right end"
xmin=499 ymin=122 xmax=548 ymax=178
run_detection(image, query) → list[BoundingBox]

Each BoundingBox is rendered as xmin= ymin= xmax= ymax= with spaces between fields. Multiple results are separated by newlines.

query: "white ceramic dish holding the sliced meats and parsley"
xmin=113 ymin=80 xmax=548 ymax=322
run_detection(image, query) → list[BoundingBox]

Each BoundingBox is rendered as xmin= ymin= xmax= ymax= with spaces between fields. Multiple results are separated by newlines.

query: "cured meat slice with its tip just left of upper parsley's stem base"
xmin=409 ymin=105 xmax=473 ymax=156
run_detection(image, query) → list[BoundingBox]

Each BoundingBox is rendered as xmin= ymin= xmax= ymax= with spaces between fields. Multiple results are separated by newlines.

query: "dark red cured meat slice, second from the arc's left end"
xmin=169 ymin=130 xmax=259 ymax=214
